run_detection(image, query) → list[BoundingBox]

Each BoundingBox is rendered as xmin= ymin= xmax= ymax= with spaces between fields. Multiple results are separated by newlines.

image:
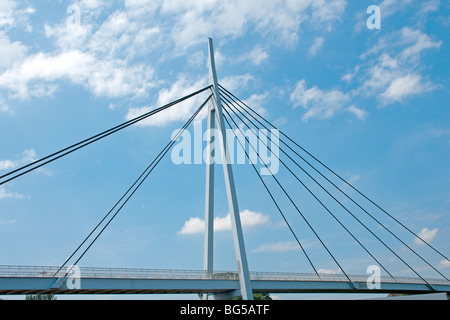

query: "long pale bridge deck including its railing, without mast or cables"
xmin=0 ymin=266 xmax=450 ymax=295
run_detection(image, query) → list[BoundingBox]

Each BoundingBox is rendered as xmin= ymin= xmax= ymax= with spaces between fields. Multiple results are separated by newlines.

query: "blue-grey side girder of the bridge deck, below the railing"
xmin=0 ymin=278 xmax=450 ymax=295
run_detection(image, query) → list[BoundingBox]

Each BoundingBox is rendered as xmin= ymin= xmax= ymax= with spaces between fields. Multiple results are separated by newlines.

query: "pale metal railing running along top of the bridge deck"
xmin=0 ymin=265 xmax=450 ymax=285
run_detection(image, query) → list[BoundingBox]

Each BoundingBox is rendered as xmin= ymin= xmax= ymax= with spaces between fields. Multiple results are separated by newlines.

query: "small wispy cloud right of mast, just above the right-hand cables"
xmin=290 ymin=79 xmax=350 ymax=121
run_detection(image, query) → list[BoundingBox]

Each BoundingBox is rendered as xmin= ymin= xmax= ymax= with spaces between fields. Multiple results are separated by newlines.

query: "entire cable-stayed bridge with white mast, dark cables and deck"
xmin=0 ymin=39 xmax=450 ymax=299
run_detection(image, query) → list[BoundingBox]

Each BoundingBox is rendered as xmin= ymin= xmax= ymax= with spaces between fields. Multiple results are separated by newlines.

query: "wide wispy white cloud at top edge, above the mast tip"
xmin=161 ymin=0 xmax=347 ymax=47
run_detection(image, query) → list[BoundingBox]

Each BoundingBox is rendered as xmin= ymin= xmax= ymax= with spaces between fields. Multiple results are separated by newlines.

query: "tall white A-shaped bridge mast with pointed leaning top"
xmin=204 ymin=38 xmax=253 ymax=300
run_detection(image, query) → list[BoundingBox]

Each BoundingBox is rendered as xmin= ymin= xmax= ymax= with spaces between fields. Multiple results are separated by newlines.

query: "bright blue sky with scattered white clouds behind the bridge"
xmin=0 ymin=0 xmax=450 ymax=298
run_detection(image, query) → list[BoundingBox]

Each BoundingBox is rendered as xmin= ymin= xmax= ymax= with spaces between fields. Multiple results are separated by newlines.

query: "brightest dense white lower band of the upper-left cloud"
xmin=0 ymin=50 xmax=153 ymax=99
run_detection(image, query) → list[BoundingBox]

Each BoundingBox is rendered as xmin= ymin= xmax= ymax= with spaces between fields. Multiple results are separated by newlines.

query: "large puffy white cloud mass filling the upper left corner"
xmin=0 ymin=0 xmax=159 ymax=99
